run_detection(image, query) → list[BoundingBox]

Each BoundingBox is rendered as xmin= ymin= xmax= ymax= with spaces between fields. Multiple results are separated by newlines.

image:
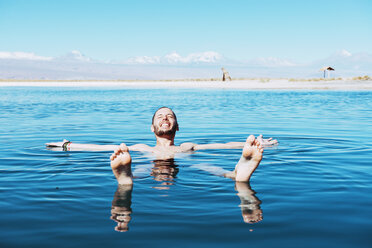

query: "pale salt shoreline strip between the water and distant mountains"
xmin=0 ymin=79 xmax=372 ymax=90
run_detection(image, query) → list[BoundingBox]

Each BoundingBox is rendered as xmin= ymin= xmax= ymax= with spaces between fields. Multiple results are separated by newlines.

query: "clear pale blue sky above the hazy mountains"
xmin=0 ymin=0 xmax=372 ymax=62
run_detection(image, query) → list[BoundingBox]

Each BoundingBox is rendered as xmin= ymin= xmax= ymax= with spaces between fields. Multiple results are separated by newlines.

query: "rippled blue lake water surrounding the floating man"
xmin=0 ymin=87 xmax=372 ymax=248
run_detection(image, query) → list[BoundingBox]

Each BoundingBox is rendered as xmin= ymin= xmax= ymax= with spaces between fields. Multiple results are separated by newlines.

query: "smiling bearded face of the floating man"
xmin=152 ymin=108 xmax=178 ymax=136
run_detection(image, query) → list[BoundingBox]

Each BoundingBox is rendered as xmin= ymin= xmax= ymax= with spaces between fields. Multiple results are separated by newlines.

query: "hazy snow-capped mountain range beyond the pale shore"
xmin=0 ymin=50 xmax=372 ymax=80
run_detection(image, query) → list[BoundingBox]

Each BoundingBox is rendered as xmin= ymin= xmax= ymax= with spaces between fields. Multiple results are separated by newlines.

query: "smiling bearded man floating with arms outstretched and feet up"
xmin=46 ymin=107 xmax=277 ymax=185
